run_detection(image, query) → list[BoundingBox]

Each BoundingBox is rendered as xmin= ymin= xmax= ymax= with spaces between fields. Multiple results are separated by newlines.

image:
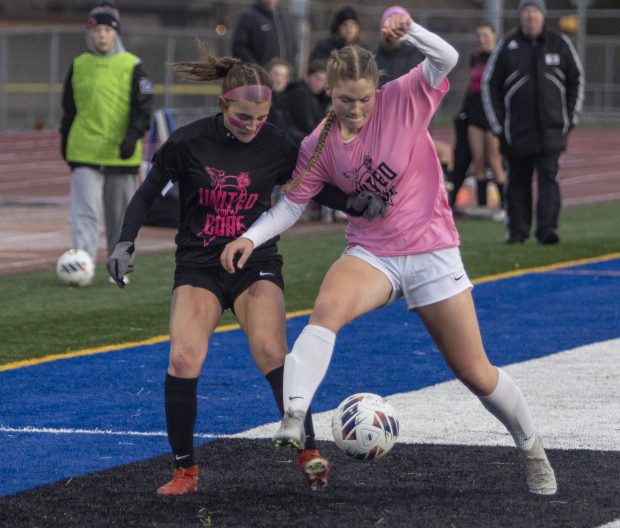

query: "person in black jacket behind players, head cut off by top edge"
xmin=232 ymin=0 xmax=297 ymax=67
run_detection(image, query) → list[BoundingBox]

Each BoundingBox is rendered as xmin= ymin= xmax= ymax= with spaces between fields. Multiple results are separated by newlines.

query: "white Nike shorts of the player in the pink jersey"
xmin=343 ymin=246 xmax=473 ymax=310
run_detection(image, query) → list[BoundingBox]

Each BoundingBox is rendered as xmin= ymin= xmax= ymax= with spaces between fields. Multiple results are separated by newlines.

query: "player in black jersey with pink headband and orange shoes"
xmin=108 ymin=45 xmax=383 ymax=495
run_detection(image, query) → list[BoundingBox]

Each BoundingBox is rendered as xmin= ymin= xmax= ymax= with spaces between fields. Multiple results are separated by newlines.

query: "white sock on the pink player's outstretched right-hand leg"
xmin=478 ymin=369 xmax=536 ymax=449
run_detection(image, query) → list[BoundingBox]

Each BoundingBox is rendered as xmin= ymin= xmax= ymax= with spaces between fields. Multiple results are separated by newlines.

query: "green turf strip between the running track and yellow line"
xmin=0 ymin=202 xmax=620 ymax=365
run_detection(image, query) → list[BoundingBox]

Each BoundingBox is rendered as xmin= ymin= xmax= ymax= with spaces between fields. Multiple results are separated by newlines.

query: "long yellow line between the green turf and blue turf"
xmin=0 ymin=253 xmax=620 ymax=372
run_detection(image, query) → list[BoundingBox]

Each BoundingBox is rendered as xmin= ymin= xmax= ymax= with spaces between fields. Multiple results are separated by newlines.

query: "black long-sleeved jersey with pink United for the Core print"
xmin=120 ymin=114 xmax=348 ymax=266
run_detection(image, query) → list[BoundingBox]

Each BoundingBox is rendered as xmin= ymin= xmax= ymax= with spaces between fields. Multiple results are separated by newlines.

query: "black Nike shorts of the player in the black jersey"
xmin=173 ymin=254 xmax=284 ymax=310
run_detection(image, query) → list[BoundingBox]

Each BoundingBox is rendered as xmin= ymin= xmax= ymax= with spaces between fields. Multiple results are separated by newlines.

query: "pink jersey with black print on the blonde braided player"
xmin=286 ymin=66 xmax=459 ymax=255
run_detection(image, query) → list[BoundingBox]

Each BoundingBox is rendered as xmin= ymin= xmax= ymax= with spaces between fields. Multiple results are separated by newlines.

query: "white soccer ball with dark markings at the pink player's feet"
xmin=332 ymin=392 xmax=399 ymax=460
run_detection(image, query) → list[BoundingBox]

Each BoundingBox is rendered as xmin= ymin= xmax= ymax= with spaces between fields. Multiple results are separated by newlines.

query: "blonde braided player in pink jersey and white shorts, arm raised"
xmin=221 ymin=9 xmax=557 ymax=495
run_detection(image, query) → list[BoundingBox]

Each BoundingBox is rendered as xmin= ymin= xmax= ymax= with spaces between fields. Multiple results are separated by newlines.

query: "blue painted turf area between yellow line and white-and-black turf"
xmin=0 ymin=259 xmax=620 ymax=495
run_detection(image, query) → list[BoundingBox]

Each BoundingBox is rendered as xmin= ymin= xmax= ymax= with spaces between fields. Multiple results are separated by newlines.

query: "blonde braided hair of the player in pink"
xmin=287 ymin=44 xmax=379 ymax=189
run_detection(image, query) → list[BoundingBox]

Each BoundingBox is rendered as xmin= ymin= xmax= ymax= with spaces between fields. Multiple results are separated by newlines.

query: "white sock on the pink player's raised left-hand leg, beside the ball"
xmin=283 ymin=325 xmax=336 ymax=412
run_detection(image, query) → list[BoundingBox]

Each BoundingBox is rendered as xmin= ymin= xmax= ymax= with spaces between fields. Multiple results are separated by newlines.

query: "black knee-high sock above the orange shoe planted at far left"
xmin=164 ymin=374 xmax=198 ymax=467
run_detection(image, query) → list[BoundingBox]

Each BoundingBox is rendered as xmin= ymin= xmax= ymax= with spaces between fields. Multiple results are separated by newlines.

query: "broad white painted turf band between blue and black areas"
xmin=235 ymin=339 xmax=620 ymax=451
